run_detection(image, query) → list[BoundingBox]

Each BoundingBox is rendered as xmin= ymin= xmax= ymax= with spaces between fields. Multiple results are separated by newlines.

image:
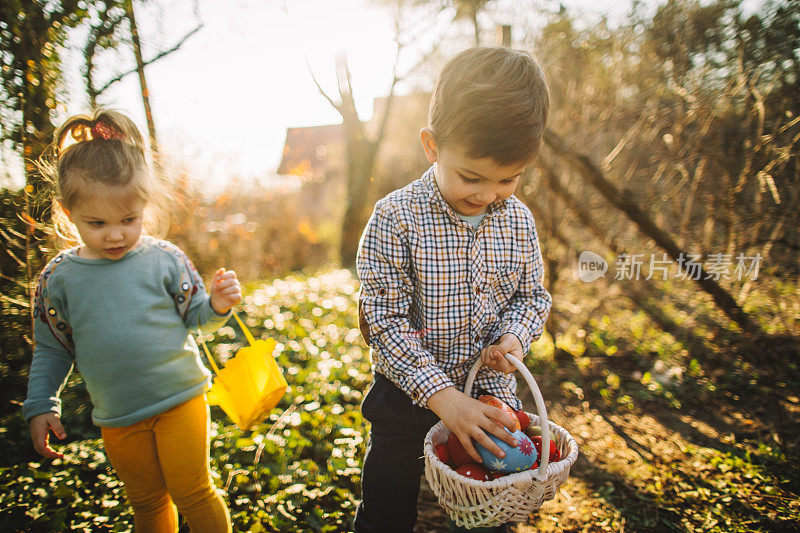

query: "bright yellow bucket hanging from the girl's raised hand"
xmin=203 ymin=313 xmax=287 ymax=430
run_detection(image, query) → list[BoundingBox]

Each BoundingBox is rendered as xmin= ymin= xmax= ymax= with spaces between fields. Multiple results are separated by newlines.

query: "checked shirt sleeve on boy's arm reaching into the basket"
xmin=357 ymin=203 xmax=453 ymax=407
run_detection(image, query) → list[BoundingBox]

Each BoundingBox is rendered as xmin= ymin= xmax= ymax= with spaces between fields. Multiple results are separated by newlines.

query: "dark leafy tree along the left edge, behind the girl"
xmin=0 ymin=0 xmax=87 ymax=414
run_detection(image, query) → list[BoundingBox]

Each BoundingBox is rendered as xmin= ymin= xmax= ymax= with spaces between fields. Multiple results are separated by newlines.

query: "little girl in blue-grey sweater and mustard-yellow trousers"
xmin=22 ymin=111 xmax=242 ymax=532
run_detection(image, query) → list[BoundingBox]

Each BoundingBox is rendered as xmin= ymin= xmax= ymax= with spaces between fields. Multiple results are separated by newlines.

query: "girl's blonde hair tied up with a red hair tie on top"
xmin=40 ymin=109 xmax=169 ymax=244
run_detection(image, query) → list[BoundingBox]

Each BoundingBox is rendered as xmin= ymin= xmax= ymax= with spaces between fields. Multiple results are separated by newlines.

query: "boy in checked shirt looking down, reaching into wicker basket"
xmin=355 ymin=47 xmax=551 ymax=533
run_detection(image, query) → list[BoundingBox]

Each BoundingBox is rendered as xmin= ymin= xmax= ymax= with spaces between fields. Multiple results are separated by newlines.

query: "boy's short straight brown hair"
xmin=428 ymin=47 xmax=550 ymax=165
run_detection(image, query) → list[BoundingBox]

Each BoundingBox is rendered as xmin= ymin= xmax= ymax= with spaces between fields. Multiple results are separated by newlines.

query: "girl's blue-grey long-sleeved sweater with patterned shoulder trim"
xmin=22 ymin=236 xmax=230 ymax=427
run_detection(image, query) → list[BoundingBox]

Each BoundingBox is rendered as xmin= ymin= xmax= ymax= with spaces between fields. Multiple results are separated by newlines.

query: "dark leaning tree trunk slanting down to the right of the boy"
xmin=544 ymin=129 xmax=761 ymax=333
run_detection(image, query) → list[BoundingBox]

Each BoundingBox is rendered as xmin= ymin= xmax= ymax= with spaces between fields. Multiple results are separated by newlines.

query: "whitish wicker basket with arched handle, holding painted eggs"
xmin=424 ymin=356 xmax=578 ymax=528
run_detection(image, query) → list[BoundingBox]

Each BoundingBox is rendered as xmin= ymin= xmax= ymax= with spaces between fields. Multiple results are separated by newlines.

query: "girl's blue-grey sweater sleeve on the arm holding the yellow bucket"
xmin=159 ymin=241 xmax=233 ymax=333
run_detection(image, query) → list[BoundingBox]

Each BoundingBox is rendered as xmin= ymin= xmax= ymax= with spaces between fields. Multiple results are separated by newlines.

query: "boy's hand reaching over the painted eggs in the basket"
xmin=428 ymin=387 xmax=517 ymax=463
